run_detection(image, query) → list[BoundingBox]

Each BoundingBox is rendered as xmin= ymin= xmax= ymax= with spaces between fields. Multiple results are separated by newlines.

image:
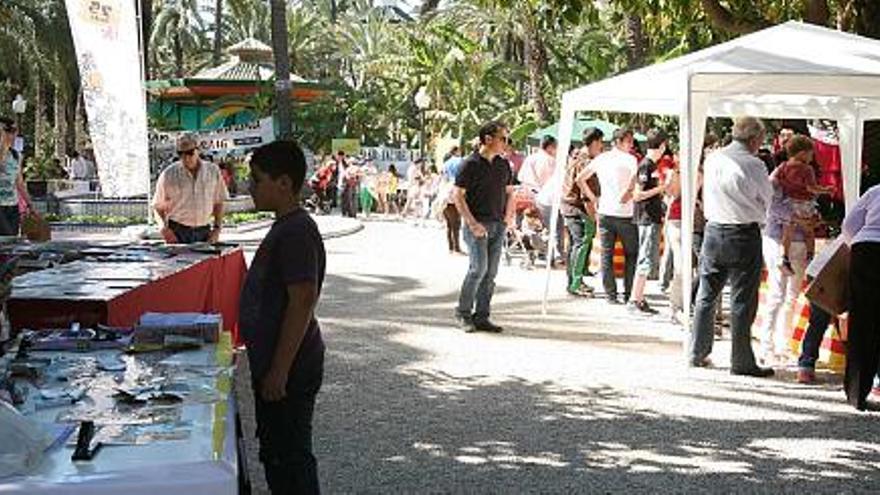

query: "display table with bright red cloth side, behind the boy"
xmin=7 ymin=247 xmax=247 ymax=342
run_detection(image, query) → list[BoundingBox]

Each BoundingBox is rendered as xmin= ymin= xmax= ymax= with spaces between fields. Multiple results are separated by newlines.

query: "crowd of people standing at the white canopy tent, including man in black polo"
xmin=440 ymin=117 xmax=880 ymax=409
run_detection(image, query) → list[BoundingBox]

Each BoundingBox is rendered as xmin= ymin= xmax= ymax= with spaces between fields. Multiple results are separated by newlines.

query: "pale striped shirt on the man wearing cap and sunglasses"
xmin=153 ymin=161 xmax=228 ymax=227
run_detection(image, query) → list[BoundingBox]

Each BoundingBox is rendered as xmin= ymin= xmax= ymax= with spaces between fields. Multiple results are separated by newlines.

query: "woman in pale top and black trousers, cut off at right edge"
xmin=843 ymin=186 xmax=880 ymax=410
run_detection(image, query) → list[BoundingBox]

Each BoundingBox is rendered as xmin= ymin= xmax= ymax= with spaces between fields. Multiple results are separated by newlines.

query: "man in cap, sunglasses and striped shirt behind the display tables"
xmin=153 ymin=135 xmax=228 ymax=244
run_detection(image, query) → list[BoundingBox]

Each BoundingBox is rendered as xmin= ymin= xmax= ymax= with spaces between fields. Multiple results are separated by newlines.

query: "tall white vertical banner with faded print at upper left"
xmin=65 ymin=0 xmax=150 ymax=197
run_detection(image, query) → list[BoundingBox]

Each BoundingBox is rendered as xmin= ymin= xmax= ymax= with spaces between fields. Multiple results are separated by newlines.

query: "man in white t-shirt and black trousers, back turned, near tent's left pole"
xmin=584 ymin=128 xmax=639 ymax=304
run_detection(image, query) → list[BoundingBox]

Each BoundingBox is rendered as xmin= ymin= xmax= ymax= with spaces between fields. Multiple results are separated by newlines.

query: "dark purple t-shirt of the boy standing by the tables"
xmin=239 ymin=209 xmax=326 ymax=379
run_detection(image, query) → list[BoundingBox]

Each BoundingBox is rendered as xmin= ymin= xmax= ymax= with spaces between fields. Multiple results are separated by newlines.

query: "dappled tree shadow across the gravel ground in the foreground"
xmin=315 ymin=275 xmax=880 ymax=493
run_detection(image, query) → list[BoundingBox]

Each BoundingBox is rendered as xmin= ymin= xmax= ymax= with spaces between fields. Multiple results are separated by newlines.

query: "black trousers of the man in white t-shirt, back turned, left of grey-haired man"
xmin=599 ymin=215 xmax=639 ymax=301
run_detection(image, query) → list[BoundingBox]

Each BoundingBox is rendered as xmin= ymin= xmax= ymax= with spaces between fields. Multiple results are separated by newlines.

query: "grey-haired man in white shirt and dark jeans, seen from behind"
xmin=688 ymin=117 xmax=773 ymax=377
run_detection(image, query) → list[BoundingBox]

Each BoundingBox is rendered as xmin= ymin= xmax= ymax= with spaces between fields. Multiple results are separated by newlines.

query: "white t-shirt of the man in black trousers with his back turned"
xmin=589 ymin=148 xmax=639 ymax=218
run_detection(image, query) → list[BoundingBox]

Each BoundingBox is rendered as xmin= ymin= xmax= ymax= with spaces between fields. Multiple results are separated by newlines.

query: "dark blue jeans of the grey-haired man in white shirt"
xmin=689 ymin=223 xmax=764 ymax=372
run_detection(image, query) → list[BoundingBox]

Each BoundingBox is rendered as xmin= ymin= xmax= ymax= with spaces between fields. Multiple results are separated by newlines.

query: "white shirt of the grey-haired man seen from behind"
xmin=703 ymin=141 xmax=773 ymax=225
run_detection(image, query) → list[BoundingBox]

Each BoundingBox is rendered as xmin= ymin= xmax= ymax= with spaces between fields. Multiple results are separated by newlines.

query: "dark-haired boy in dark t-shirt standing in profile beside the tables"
xmin=239 ymin=141 xmax=325 ymax=494
